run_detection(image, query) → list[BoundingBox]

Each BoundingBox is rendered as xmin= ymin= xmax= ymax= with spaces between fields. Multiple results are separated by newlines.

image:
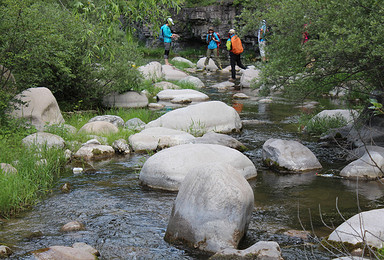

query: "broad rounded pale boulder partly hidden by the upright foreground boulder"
xmin=139 ymin=144 xmax=257 ymax=191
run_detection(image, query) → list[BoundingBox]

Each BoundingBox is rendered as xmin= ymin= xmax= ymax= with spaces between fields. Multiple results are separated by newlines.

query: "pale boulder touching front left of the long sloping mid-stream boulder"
xmin=129 ymin=127 xmax=195 ymax=152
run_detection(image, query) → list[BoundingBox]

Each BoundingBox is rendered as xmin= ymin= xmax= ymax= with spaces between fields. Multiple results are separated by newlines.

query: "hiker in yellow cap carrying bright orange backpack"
xmin=226 ymin=29 xmax=247 ymax=81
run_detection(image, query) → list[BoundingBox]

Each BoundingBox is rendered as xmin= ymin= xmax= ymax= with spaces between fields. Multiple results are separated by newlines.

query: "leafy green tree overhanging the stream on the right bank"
xmin=239 ymin=0 xmax=384 ymax=101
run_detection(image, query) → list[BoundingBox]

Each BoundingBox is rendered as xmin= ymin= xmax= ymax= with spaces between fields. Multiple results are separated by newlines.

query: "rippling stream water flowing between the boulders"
xmin=0 ymin=68 xmax=384 ymax=259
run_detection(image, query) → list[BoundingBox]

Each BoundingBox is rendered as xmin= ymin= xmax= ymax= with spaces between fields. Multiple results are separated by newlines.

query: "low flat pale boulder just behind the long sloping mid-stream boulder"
xmin=157 ymin=89 xmax=209 ymax=102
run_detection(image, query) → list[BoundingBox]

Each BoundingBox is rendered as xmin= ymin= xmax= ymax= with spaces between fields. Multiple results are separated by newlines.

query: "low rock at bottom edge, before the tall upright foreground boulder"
xmin=209 ymin=241 xmax=283 ymax=260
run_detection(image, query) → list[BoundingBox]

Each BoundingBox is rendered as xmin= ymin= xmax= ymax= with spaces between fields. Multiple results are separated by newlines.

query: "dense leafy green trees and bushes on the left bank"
xmin=0 ymin=0 xmax=182 ymax=112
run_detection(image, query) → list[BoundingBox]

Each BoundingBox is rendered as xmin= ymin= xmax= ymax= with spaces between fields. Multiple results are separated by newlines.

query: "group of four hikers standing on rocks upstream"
xmin=160 ymin=18 xmax=267 ymax=81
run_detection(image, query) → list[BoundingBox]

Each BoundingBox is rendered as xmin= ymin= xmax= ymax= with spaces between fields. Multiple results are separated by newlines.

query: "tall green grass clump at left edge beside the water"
xmin=0 ymin=135 xmax=65 ymax=218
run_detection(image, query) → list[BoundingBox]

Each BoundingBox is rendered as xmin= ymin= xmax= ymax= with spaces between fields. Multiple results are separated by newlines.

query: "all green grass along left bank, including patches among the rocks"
xmin=0 ymin=108 xmax=159 ymax=218
